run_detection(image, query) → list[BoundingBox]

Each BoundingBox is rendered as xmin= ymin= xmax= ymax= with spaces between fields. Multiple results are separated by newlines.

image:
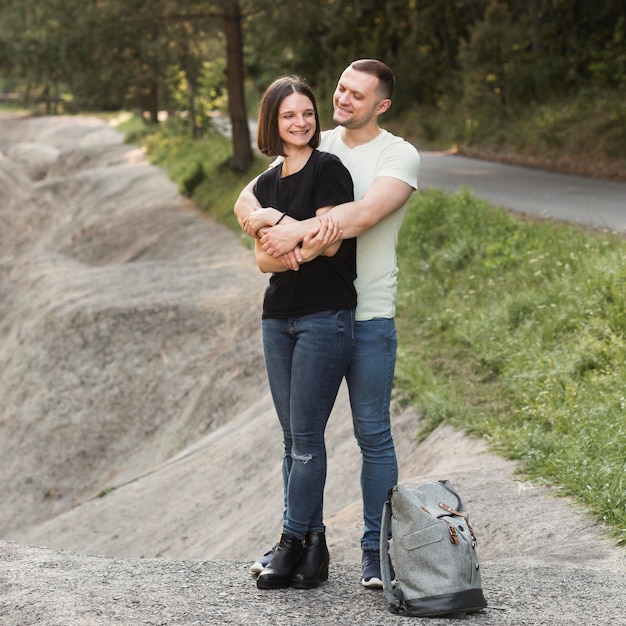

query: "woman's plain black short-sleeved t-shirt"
xmin=254 ymin=150 xmax=356 ymax=318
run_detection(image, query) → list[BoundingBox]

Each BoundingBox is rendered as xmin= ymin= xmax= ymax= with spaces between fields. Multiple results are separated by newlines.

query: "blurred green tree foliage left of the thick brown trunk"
xmin=0 ymin=0 xmax=224 ymax=121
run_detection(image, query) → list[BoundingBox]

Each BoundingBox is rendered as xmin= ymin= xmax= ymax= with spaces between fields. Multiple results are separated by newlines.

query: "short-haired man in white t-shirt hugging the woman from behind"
xmin=235 ymin=59 xmax=420 ymax=588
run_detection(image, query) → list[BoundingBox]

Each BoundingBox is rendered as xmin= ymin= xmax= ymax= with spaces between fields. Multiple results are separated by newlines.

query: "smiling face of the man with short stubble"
xmin=333 ymin=67 xmax=384 ymax=129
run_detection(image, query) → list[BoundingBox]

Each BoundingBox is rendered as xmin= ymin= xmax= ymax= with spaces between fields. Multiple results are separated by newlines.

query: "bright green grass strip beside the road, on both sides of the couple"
xmin=125 ymin=117 xmax=626 ymax=545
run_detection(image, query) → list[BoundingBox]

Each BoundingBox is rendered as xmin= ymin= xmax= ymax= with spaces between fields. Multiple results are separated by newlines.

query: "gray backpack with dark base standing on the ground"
xmin=380 ymin=480 xmax=487 ymax=618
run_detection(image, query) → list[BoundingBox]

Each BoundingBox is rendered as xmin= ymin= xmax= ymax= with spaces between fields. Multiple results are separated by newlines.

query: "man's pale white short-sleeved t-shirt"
xmin=319 ymin=126 xmax=420 ymax=321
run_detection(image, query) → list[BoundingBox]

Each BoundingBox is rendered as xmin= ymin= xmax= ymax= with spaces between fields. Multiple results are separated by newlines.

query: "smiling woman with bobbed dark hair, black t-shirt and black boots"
xmin=244 ymin=77 xmax=356 ymax=589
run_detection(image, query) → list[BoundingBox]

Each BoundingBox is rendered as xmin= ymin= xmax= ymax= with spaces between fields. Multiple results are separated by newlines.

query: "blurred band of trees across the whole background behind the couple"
xmin=0 ymin=0 xmax=626 ymax=167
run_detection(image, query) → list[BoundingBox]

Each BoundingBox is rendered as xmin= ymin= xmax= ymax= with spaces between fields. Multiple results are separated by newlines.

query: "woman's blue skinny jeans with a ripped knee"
xmin=261 ymin=310 xmax=354 ymax=538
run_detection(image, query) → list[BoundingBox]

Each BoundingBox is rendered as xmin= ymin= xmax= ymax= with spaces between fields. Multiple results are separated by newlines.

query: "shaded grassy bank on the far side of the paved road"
xmin=388 ymin=91 xmax=626 ymax=181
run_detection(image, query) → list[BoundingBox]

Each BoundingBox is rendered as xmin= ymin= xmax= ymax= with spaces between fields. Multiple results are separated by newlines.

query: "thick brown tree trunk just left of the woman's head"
xmin=224 ymin=0 xmax=252 ymax=172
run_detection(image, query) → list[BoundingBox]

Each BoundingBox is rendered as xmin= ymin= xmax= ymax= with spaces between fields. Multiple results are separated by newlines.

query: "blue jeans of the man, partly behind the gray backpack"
xmin=346 ymin=318 xmax=398 ymax=550
